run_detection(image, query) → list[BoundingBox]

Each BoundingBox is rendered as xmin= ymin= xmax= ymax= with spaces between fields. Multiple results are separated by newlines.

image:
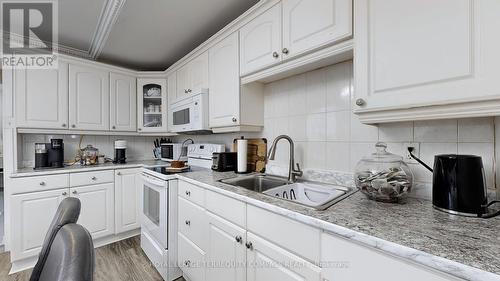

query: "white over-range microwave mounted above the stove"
xmin=170 ymin=89 xmax=210 ymax=133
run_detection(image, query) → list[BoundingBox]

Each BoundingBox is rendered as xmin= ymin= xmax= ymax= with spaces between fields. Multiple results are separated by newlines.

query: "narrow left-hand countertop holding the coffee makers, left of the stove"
xmin=10 ymin=159 xmax=167 ymax=178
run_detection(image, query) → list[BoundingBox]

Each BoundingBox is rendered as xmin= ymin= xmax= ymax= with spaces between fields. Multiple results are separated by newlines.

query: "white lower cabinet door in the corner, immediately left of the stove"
xmin=115 ymin=169 xmax=142 ymax=234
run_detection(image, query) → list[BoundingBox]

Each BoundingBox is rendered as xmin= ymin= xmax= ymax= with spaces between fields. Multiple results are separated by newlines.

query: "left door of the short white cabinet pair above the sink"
xmin=240 ymin=2 xmax=282 ymax=75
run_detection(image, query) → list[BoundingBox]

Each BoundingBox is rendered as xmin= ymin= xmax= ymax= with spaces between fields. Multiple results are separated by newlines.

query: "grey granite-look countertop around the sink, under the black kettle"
xmin=179 ymin=170 xmax=500 ymax=280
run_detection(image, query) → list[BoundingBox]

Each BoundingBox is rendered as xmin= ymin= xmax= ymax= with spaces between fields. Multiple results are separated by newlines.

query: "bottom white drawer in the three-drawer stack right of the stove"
xmin=178 ymin=233 xmax=205 ymax=281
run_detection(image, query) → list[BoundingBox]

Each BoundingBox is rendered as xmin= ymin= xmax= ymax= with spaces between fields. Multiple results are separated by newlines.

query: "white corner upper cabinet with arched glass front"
xmin=137 ymin=78 xmax=168 ymax=133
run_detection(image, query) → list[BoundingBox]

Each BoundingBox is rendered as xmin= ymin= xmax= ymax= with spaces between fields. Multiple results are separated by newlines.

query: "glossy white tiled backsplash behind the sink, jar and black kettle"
xmin=263 ymin=62 xmax=495 ymax=188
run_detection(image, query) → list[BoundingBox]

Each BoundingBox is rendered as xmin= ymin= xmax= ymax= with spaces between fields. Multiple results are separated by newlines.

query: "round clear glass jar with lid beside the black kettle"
xmin=354 ymin=142 xmax=413 ymax=203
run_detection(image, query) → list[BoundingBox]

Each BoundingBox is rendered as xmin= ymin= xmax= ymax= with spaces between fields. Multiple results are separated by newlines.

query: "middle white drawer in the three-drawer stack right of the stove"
xmin=179 ymin=197 xmax=208 ymax=250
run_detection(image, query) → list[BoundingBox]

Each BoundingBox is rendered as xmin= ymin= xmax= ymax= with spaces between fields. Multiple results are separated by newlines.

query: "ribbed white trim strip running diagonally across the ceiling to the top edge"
xmin=89 ymin=0 xmax=126 ymax=60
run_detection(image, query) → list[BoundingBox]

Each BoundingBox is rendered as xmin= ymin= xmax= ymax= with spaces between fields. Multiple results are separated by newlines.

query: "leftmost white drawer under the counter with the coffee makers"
xmin=12 ymin=174 xmax=69 ymax=194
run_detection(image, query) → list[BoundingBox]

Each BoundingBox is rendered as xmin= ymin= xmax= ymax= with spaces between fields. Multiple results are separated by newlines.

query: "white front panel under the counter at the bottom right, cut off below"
xmin=321 ymin=233 xmax=458 ymax=281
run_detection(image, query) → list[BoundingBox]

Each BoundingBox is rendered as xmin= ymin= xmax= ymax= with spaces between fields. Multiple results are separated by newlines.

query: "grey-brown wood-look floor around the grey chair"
xmin=0 ymin=236 xmax=184 ymax=281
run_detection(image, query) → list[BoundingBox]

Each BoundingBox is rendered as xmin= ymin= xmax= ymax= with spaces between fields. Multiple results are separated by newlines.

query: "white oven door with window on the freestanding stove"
xmin=141 ymin=173 xmax=168 ymax=249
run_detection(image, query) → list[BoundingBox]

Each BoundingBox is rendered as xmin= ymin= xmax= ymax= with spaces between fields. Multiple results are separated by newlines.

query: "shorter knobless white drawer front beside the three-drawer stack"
xmin=206 ymin=190 xmax=246 ymax=227
